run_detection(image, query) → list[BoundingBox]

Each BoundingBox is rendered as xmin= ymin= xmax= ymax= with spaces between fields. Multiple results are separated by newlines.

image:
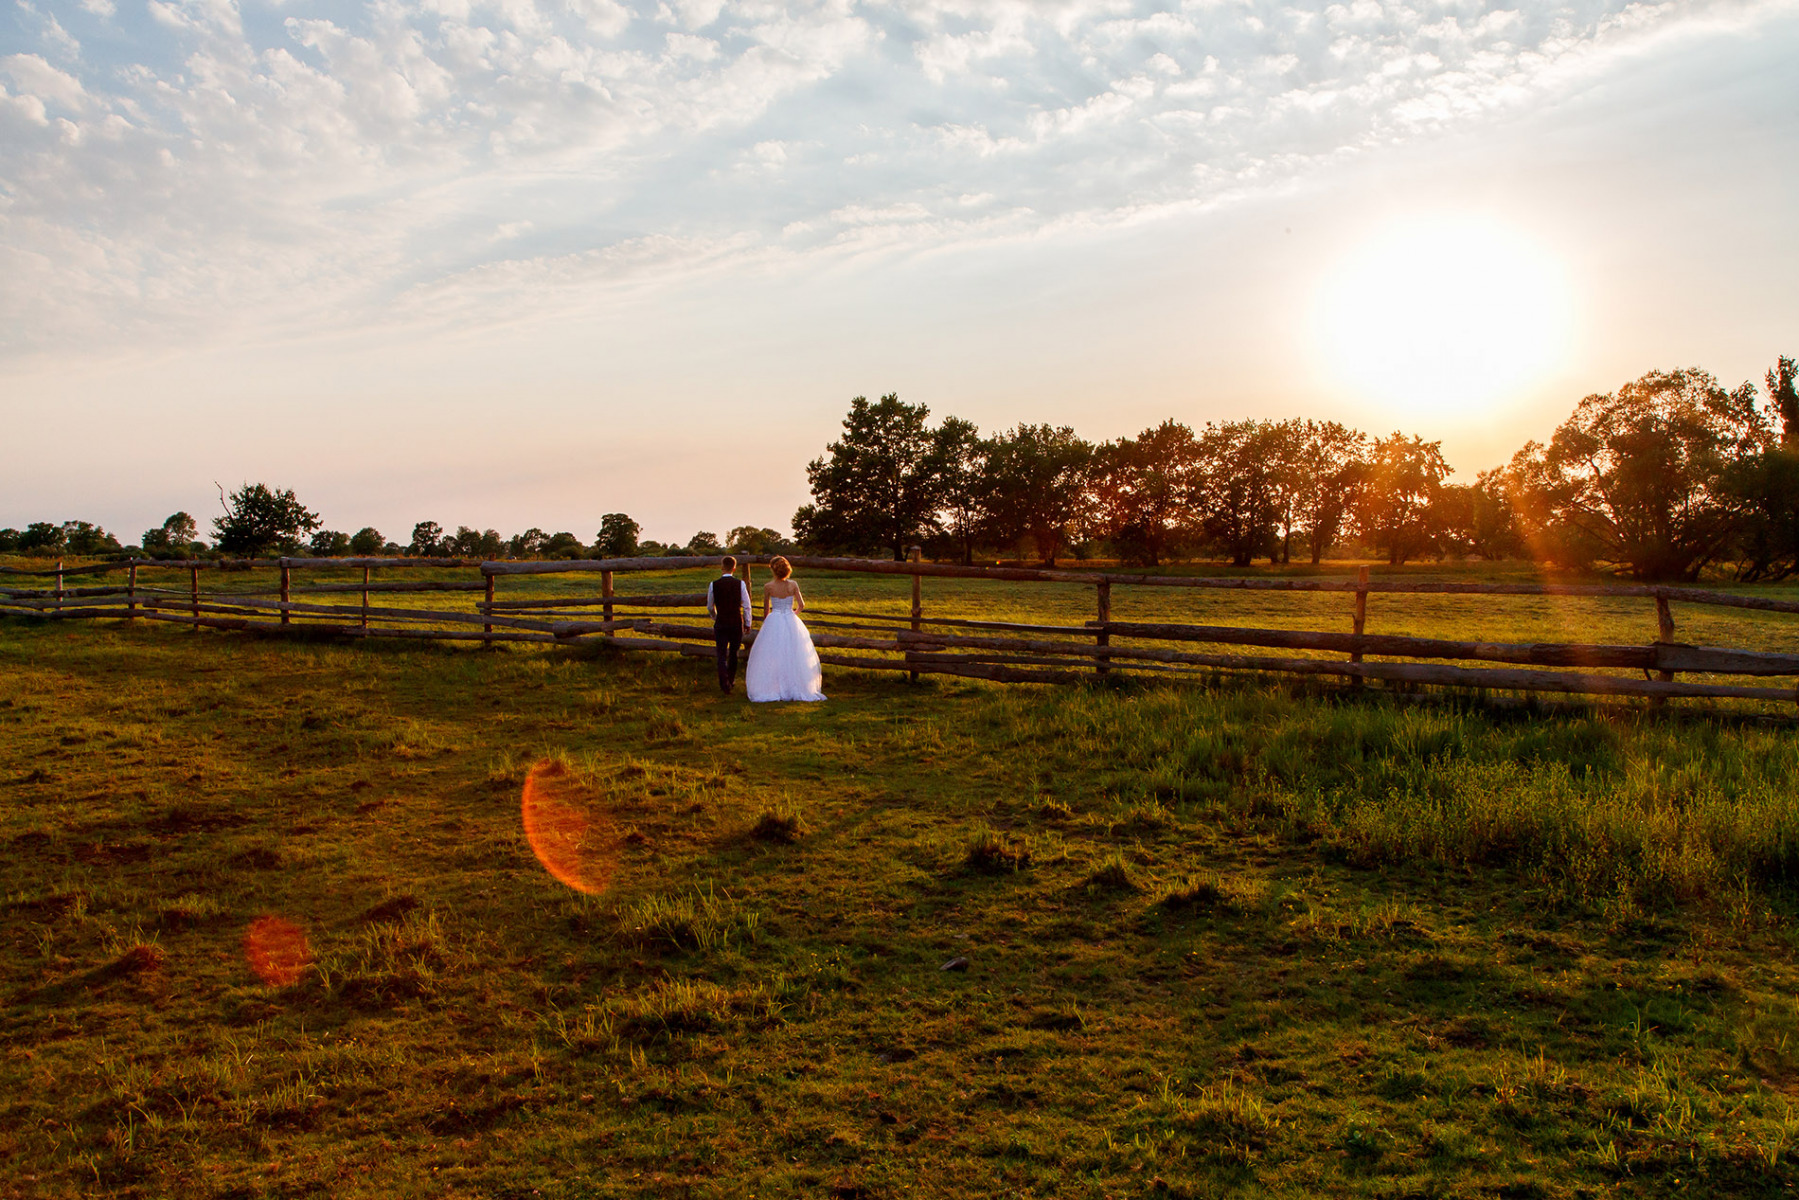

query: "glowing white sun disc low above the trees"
xmin=1313 ymin=216 xmax=1572 ymax=419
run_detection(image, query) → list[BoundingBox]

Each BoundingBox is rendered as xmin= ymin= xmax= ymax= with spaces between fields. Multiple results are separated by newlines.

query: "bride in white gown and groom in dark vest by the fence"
xmin=705 ymin=554 xmax=824 ymax=702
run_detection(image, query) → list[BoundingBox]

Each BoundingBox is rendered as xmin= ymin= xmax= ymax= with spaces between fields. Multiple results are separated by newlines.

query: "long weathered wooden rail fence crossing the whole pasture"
xmin=0 ymin=551 xmax=1799 ymax=703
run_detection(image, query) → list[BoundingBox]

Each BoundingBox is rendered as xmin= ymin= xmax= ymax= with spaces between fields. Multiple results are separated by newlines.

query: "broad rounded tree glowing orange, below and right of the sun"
xmin=1515 ymin=369 xmax=1772 ymax=579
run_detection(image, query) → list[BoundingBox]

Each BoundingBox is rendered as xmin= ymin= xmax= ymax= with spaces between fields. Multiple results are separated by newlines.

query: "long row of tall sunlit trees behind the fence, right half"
xmin=793 ymin=358 xmax=1799 ymax=581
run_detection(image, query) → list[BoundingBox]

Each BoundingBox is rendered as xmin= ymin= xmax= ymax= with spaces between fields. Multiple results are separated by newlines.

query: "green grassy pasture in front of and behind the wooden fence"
xmin=10 ymin=578 xmax=1799 ymax=1196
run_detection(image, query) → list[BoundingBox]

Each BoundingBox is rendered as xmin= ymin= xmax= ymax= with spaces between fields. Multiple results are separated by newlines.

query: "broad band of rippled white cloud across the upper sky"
xmin=0 ymin=0 xmax=1781 ymax=354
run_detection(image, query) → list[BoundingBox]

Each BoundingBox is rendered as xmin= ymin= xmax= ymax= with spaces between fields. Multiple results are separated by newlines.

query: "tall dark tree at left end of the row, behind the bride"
xmin=793 ymin=394 xmax=964 ymax=561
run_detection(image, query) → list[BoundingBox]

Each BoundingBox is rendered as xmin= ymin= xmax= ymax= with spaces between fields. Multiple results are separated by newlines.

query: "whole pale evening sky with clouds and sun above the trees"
xmin=0 ymin=0 xmax=1799 ymax=542
